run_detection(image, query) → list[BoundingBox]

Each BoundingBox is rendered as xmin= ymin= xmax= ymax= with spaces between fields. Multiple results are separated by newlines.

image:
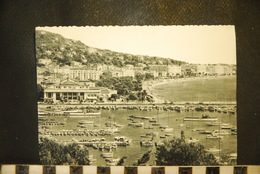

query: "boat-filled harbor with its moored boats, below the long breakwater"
xmin=39 ymin=104 xmax=237 ymax=165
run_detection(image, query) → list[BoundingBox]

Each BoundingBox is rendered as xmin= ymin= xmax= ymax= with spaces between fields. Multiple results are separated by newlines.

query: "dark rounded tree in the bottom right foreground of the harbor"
xmin=156 ymin=138 xmax=218 ymax=165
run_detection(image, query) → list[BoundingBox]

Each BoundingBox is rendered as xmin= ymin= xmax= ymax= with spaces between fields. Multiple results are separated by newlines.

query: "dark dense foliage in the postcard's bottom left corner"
xmin=39 ymin=138 xmax=89 ymax=165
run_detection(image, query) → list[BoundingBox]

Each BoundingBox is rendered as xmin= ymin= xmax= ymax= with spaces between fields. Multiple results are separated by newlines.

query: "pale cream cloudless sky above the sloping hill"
xmin=36 ymin=25 xmax=236 ymax=64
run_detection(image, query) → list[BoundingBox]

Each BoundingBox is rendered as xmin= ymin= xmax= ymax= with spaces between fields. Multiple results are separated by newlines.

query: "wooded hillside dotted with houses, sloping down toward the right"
xmin=36 ymin=31 xmax=186 ymax=67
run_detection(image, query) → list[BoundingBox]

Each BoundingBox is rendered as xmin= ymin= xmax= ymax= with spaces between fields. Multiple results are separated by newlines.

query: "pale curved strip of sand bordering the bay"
xmin=142 ymin=75 xmax=236 ymax=103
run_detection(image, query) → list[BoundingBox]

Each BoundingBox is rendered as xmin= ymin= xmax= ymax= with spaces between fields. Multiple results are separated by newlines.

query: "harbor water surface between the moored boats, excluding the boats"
xmin=39 ymin=109 xmax=237 ymax=165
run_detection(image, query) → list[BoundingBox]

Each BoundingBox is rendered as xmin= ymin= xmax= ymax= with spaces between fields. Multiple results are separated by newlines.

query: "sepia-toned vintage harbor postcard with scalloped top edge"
xmin=35 ymin=25 xmax=237 ymax=166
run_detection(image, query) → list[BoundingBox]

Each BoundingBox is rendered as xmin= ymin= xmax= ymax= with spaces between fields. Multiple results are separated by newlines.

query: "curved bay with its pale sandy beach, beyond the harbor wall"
xmin=143 ymin=76 xmax=236 ymax=103
